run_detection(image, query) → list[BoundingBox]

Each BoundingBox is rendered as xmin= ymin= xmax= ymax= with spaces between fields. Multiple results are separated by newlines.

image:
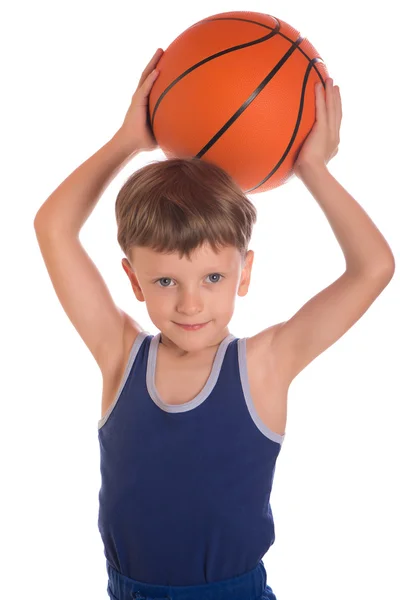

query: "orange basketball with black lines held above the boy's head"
xmin=149 ymin=11 xmax=329 ymax=193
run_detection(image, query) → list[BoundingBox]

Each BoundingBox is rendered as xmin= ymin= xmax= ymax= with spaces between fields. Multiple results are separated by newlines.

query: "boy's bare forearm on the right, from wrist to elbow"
xmin=297 ymin=165 xmax=394 ymax=273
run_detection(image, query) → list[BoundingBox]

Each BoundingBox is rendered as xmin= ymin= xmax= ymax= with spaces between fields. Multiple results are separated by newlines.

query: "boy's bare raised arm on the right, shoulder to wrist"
xmin=271 ymin=164 xmax=395 ymax=385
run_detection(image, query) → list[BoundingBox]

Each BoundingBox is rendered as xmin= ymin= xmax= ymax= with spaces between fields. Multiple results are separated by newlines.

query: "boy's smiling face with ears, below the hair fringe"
xmin=122 ymin=243 xmax=254 ymax=355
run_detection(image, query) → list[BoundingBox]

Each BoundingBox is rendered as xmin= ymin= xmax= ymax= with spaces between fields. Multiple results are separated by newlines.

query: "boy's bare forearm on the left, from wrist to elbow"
xmin=35 ymin=132 xmax=140 ymax=235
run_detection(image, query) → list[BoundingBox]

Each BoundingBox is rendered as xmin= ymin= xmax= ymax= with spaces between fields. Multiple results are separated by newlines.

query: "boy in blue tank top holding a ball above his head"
xmin=35 ymin=49 xmax=395 ymax=600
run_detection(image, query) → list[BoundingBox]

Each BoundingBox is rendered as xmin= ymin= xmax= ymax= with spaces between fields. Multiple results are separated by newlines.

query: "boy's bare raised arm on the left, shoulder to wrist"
xmin=34 ymin=138 xmax=140 ymax=376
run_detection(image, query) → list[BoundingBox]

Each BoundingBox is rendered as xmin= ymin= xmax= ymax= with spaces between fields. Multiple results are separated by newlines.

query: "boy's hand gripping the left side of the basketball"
xmin=114 ymin=48 xmax=164 ymax=151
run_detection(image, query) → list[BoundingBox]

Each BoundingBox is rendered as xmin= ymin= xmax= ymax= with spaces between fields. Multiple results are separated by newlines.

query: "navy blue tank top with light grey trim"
xmin=98 ymin=331 xmax=285 ymax=586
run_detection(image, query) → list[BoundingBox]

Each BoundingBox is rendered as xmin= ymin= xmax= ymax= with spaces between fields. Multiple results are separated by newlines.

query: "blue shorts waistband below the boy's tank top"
xmin=106 ymin=561 xmax=276 ymax=600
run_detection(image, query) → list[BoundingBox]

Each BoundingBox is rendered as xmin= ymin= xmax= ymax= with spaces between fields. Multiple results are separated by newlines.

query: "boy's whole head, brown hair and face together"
xmin=115 ymin=158 xmax=257 ymax=351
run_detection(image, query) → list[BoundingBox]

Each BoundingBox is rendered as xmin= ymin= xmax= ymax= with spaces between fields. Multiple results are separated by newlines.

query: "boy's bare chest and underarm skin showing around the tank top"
xmin=101 ymin=325 xmax=289 ymax=435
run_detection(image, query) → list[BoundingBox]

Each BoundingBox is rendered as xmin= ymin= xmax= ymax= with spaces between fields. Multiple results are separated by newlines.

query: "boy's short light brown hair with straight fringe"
xmin=115 ymin=157 xmax=257 ymax=262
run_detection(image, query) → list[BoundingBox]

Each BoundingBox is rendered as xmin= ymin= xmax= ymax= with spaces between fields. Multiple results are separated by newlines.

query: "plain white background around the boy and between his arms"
xmin=0 ymin=0 xmax=400 ymax=600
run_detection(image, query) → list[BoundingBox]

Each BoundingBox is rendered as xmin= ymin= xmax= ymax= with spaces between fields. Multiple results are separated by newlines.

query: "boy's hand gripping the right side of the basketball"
xmin=293 ymin=77 xmax=342 ymax=175
